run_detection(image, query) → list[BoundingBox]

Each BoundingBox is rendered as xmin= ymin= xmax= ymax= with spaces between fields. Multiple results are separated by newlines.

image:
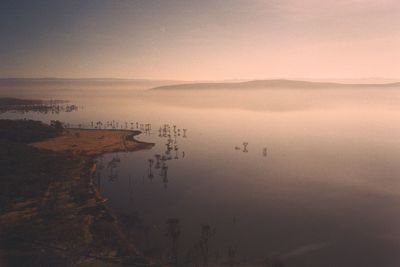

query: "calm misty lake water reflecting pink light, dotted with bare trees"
xmin=1 ymin=88 xmax=400 ymax=267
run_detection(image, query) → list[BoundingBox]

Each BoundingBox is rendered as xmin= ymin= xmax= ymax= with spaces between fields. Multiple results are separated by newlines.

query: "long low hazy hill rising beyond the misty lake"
xmin=150 ymin=80 xmax=400 ymax=91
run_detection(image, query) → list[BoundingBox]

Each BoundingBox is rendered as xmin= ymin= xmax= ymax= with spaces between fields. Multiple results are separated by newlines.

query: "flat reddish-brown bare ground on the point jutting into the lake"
xmin=31 ymin=129 xmax=154 ymax=156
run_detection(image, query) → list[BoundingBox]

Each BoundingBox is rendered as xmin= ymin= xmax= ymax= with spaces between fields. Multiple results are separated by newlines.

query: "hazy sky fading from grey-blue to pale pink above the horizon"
xmin=0 ymin=0 xmax=400 ymax=80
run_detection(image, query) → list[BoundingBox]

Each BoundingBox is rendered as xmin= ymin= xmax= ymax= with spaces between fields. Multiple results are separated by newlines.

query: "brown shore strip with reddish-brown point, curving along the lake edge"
xmin=0 ymin=128 xmax=157 ymax=266
